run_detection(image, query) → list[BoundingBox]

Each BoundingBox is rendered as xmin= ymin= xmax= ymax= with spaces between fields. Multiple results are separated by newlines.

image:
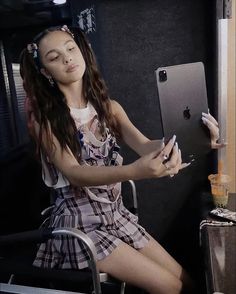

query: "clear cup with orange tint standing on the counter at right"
xmin=208 ymin=174 xmax=230 ymax=208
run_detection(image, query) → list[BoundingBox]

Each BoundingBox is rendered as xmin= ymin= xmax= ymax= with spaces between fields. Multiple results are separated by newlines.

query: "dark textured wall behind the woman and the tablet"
xmin=75 ymin=0 xmax=214 ymax=234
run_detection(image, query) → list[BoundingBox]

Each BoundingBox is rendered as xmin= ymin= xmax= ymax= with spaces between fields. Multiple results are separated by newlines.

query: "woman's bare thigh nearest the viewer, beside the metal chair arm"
xmin=98 ymin=243 xmax=182 ymax=294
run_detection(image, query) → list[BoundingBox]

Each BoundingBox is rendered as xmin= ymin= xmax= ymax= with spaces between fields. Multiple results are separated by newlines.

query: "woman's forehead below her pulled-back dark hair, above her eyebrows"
xmin=39 ymin=31 xmax=74 ymax=52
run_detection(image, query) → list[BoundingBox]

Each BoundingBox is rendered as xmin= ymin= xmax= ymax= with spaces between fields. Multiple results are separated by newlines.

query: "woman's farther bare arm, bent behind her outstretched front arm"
xmin=111 ymin=100 xmax=165 ymax=156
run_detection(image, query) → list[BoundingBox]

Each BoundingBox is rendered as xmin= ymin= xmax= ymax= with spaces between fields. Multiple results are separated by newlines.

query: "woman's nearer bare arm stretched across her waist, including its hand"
xmin=34 ymin=121 xmax=186 ymax=186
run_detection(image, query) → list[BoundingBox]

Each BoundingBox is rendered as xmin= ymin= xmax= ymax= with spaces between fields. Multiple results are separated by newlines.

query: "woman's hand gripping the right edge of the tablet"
xmin=202 ymin=112 xmax=227 ymax=149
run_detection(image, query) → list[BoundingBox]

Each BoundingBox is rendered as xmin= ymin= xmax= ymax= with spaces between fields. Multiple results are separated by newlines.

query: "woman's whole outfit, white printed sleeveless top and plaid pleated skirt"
xmin=33 ymin=103 xmax=149 ymax=269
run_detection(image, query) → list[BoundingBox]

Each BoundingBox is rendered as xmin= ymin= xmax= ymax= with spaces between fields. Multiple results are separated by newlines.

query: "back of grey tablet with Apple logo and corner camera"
xmin=156 ymin=62 xmax=210 ymax=161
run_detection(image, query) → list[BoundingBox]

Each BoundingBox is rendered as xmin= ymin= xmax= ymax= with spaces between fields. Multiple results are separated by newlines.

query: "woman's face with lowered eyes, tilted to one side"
xmin=39 ymin=31 xmax=85 ymax=85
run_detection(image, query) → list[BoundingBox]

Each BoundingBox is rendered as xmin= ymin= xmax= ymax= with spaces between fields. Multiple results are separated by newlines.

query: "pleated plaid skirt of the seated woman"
xmin=33 ymin=187 xmax=149 ymax=269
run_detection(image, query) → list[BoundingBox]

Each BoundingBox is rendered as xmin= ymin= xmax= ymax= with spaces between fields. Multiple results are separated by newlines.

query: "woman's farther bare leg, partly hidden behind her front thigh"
xmin=139 ymin=234 xmax=194 ymax=289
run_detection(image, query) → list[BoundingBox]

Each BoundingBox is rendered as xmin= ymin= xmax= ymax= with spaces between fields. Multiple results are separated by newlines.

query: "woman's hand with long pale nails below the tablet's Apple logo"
xmin=133 ymin=136 xmax=190 ymax=179
